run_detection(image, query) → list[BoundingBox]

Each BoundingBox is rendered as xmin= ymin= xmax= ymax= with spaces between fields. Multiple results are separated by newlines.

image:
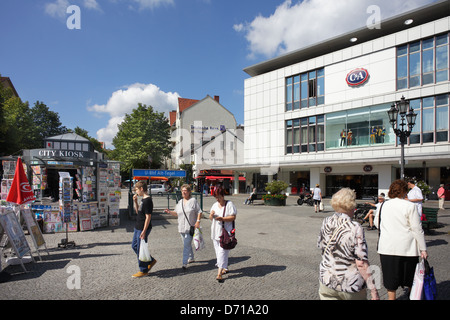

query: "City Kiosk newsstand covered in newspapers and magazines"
xmin=2 ymin=133 xmax=120 ymax=233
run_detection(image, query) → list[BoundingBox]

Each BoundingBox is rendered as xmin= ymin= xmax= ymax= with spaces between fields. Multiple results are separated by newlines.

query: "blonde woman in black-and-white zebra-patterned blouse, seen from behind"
xmin=317 ymin=188 xmax=379 ymax=300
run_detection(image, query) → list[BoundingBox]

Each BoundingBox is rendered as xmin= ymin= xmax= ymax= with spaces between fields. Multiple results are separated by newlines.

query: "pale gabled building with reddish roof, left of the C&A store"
xmin=169 ymin=96 xmax=245 ymax=190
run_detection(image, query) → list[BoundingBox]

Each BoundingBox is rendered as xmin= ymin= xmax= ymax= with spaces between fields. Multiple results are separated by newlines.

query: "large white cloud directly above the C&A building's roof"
xmin=233 ymin=0 xmax=435 ymax=58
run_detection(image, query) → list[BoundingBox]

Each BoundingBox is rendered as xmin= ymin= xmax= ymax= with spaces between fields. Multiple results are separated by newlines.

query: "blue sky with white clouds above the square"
xmin=0 ymin=0 xmax=434 ymax=148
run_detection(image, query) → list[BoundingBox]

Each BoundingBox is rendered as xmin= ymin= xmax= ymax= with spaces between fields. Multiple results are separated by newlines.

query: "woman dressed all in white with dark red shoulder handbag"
xmin=209 ymin=186 xmax=237 ymax=282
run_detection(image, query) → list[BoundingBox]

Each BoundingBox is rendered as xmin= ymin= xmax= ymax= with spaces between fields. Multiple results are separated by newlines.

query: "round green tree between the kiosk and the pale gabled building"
xmin=111 ymin=103 xmax=172 ymax=172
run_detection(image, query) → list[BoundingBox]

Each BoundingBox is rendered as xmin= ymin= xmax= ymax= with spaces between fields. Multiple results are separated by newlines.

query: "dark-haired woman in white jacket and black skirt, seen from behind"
xmin=374 ymin=180 xmax=427 ymax=300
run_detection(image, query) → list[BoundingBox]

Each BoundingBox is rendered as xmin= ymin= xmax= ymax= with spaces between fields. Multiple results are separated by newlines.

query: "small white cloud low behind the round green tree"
xmin=87 ymin=83 xmax=179 ymax=148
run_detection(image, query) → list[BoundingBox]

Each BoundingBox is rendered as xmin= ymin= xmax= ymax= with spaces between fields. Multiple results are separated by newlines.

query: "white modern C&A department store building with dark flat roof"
xmin=222 ymin=0 xmax=450 ymax=198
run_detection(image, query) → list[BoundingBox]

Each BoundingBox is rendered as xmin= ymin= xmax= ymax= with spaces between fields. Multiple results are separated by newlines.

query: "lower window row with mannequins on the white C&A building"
xmin=286 ymin=94 xmax=450 ymax=153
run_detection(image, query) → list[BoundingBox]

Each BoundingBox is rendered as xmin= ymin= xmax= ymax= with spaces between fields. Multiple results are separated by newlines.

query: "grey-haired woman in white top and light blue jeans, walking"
xmin=164 ymin=184 xmax=202 ymax=270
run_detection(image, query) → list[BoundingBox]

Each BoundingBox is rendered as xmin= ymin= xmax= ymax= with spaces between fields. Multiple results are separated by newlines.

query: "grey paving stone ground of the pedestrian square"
xmin=0 ymin=190 xmax=450 ymax=301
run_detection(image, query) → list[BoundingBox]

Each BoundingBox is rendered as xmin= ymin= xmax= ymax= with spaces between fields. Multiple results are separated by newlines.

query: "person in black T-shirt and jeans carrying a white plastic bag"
xmin=131 ymin=181 xmax=156 ymax=278
